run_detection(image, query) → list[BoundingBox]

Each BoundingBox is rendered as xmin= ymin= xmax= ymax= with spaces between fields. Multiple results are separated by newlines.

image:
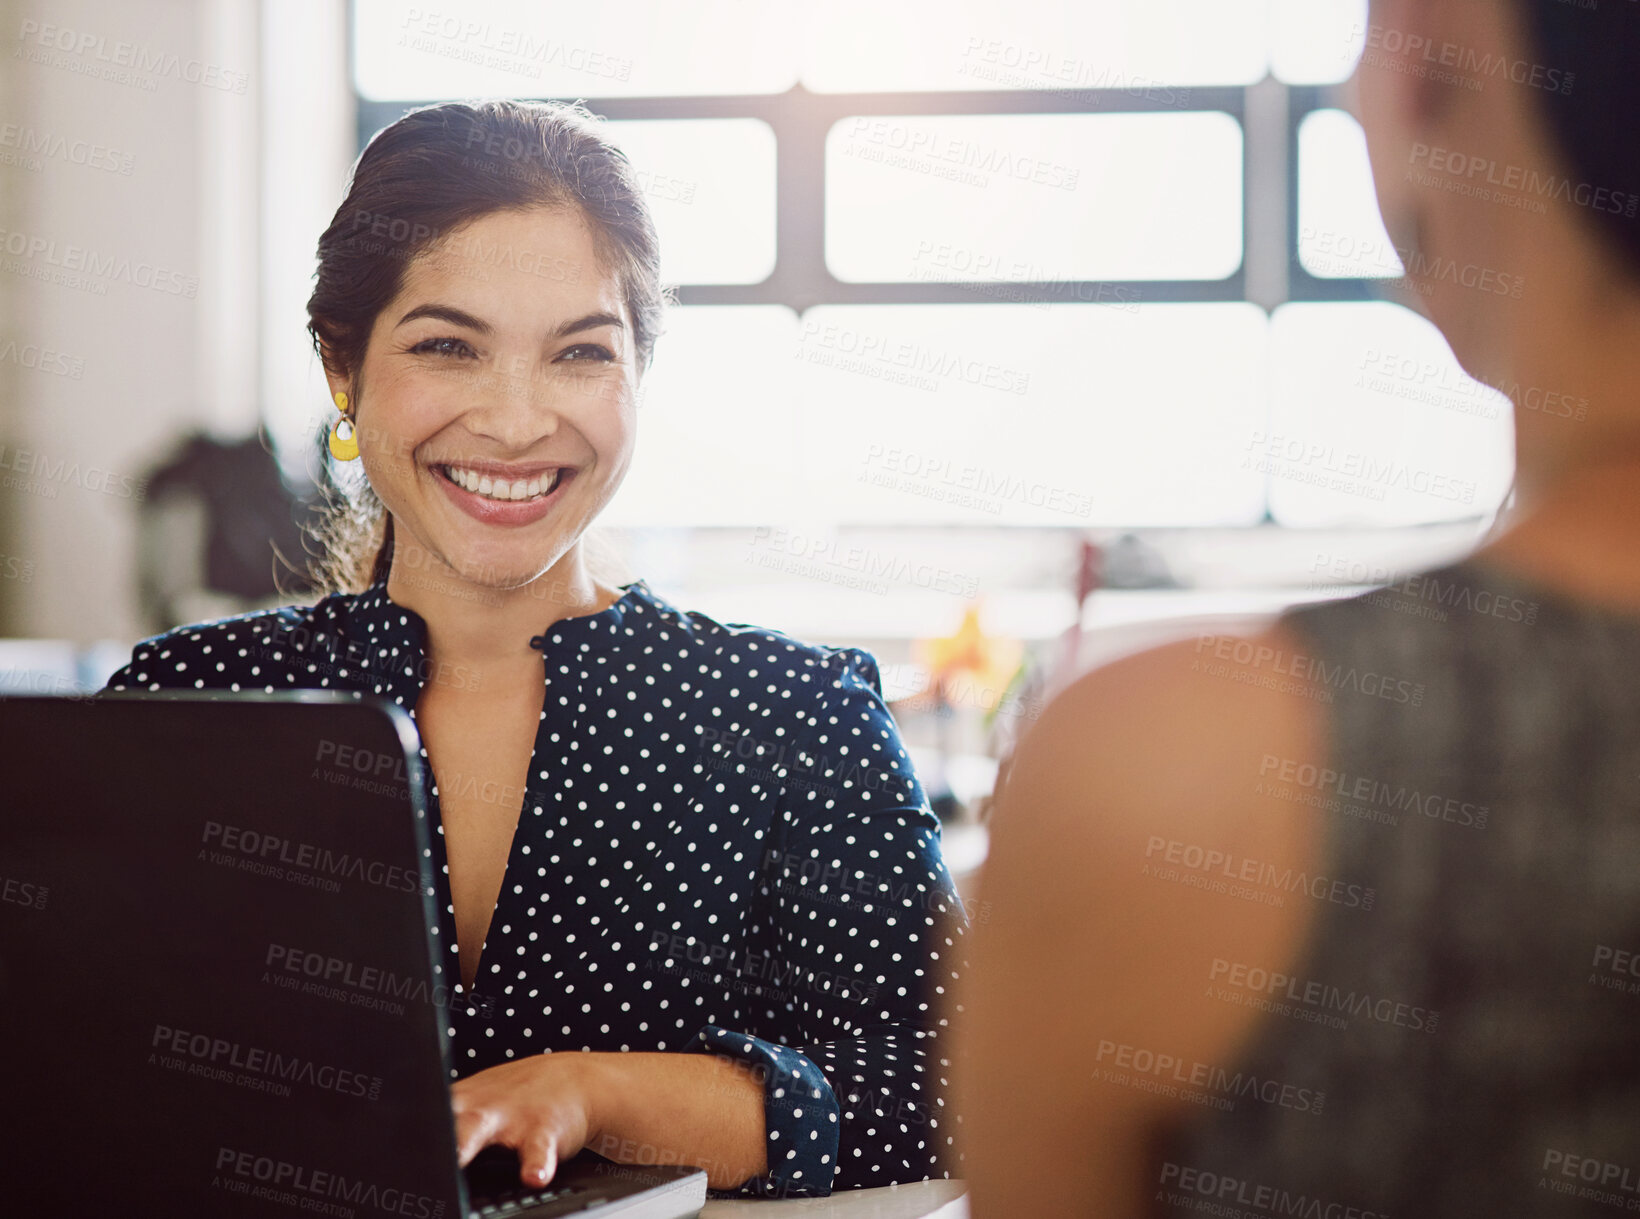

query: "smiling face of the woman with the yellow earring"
xmin=329 ymin=205 xmax=638 ymax=603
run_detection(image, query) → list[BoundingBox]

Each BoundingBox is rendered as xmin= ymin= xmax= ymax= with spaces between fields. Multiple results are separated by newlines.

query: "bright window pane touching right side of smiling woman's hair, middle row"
xmin=608 ymin=118 xmax=774 ymax=284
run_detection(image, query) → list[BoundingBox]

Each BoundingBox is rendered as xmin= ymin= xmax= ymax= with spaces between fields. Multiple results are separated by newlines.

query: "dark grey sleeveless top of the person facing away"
xmin=1148 ymin=561 xmax=1640 ymax=1219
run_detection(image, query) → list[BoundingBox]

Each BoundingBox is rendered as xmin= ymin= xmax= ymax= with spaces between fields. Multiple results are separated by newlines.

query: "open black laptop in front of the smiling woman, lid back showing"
xmin=0 ymin=692 xmax=707 ymax=1219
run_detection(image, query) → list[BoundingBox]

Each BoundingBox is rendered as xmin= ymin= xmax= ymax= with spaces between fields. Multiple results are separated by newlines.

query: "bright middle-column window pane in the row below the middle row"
xmin=795 ymin=304 xmax=1268 ymax=527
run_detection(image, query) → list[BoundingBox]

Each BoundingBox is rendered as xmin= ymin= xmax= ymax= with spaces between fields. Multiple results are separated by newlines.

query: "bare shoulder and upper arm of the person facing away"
xmin=961 ymin=625 xmax=1327 ymax=1214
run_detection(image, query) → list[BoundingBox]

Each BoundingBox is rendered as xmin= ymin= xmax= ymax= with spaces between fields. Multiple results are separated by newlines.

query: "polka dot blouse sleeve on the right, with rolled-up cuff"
xmin=690 ymin=648 xmax=964 ymax=1196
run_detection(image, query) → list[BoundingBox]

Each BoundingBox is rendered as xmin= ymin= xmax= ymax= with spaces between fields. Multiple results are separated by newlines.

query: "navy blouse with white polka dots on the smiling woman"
xmin=108 ymin=581 xmax=963 ymax=1194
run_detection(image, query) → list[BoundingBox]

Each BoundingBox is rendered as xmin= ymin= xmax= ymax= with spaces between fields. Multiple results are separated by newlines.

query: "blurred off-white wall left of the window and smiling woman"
xmin=0 ymin=0 xmax=353 ymax=641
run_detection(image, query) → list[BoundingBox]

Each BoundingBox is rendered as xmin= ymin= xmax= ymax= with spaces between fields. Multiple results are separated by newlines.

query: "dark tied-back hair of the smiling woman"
xmin=308 ymin=100 xmax=666 ymax=592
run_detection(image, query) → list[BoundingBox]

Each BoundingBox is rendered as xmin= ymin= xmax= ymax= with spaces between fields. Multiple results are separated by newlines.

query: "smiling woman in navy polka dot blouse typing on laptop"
xmin=110 ymin=102 xmax=963 ymax=1194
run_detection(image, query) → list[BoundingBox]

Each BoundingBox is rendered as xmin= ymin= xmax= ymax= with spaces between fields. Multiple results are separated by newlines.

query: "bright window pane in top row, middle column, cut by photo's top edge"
xmin=802 ymin=0 xmax=1268 ymax=93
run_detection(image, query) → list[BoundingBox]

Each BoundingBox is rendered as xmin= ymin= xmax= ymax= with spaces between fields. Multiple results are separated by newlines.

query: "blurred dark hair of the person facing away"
xmin=1515 ymin=0 xmax=1640 ymax=279
